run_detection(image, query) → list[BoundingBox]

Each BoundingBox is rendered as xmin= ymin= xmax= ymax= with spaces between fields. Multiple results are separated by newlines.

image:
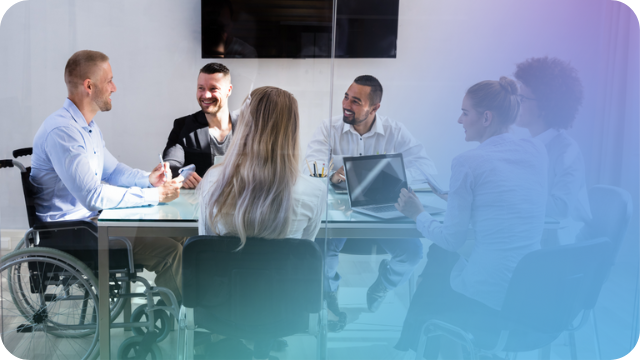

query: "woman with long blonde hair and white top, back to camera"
xmin=198 ymin=86 xmax=327 ymax=359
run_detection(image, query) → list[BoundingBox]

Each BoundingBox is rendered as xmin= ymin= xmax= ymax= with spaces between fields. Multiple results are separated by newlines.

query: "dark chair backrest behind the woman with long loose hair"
xmin=182 ymin=236 xmax=322 ymax=339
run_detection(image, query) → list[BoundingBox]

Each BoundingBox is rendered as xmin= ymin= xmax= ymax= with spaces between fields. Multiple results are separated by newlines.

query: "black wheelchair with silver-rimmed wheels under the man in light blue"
xmin=0 ymin=148 xmax=178 ymax=360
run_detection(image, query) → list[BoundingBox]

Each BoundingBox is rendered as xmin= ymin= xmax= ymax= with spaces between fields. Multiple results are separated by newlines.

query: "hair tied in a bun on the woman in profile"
xmin=466 ymin=76 xmax=520 ymax=128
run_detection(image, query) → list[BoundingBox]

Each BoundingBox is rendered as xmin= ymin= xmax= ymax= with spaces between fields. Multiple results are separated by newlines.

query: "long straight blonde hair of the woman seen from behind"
xmin=204 ymin=86 xmax=299 ymax=248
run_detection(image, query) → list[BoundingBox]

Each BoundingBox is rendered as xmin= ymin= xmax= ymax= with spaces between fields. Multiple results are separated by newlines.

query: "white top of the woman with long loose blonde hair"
xmin=198 ymin=167 xmax=327 ymax=241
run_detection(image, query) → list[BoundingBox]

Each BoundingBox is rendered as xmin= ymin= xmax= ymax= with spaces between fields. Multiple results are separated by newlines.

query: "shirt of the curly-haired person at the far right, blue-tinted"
xmin=535 ymin=129 xmax=591 ymax=222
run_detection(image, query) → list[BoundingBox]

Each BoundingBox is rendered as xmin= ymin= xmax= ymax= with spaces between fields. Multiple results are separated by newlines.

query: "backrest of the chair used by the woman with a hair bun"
xmin=502 ymin=238 xmax=613 ymax=334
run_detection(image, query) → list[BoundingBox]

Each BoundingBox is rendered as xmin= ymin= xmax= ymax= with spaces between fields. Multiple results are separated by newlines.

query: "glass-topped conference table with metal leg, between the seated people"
xmin=98 ymin=187 xmax=559 ymax=359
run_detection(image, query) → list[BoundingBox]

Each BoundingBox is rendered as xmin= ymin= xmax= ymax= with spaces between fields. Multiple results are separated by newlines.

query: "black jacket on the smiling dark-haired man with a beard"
xmin=162 ymin=110 xmax=239 ymax=177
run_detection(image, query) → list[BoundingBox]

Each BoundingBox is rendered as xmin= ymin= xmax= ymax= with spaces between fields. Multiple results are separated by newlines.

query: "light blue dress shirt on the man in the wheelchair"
xmin=30 ymin=99 xmax=159 ymax=221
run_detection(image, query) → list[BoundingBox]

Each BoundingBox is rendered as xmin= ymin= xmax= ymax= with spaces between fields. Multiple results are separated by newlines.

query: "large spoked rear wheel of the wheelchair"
xmin=0 ymin=248 xmax=98 ymax=359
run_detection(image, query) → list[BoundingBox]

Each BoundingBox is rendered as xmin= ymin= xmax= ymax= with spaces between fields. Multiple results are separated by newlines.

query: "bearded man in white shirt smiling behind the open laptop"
xmin=305 ymin=75 xmax=436 ymax=331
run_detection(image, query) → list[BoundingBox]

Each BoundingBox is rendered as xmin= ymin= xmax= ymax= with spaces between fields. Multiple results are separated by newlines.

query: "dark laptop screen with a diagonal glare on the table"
xmin=344 ymin=154 xmax=407 ymax=207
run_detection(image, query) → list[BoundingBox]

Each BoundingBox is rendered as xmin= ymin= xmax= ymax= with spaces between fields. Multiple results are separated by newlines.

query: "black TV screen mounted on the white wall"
xmin=201 ymin=0 xmax=399 ymax=58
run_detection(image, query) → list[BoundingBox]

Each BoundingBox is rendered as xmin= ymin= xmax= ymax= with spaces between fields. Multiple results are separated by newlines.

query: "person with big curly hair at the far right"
xmin=514 ymin=57 xmax=591 ymax=247
